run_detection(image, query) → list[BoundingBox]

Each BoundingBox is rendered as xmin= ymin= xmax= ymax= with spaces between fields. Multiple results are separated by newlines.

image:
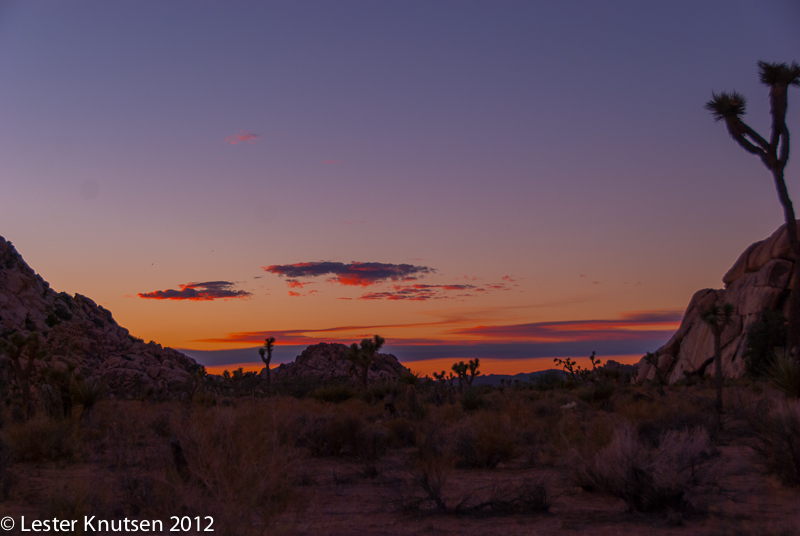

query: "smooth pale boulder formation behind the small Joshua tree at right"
xmin=637 ymin=225 xmax=800 ymax=383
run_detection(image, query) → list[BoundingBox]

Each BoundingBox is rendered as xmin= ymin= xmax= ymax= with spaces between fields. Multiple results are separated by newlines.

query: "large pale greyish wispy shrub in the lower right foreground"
xmin=570 ymin=423 xmax=714 ymax=513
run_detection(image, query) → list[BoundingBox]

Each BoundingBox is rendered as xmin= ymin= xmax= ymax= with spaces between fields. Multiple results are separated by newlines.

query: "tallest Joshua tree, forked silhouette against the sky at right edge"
xmin=706 ymin=61 xmax=800 ymax=351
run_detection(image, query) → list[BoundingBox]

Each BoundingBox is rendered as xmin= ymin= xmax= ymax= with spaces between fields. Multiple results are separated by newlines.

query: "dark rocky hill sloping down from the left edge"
xmin=0 ymin=237 xmax=196 ymax=392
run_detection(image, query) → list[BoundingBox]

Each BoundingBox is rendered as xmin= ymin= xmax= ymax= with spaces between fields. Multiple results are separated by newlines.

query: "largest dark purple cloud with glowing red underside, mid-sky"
xmin=263 ymin=261 xmax=435 ymax=287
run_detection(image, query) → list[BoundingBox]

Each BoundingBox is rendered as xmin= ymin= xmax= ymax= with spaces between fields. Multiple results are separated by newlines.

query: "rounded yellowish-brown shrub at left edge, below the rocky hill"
xmin=3 ymin=415 xmax=80 ymax=462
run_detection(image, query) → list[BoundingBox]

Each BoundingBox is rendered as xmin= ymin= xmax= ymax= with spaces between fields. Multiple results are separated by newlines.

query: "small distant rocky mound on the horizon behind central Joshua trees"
xmin=270 ymin=342 xmax=410 ymax=383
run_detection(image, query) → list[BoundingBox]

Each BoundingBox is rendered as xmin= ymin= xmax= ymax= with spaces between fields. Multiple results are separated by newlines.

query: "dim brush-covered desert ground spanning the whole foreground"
xmin=0 ymin=376 xmax=800 ymax=536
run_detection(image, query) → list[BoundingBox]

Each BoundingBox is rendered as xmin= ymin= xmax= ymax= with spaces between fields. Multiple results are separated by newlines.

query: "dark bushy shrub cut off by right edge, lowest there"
xmin=747 ymin=400 xmax=800 ymax=485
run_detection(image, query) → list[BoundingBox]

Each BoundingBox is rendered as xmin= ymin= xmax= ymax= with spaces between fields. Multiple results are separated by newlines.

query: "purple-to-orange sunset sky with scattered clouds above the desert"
xmin=0 ymin=0 xmax=800 ymax=372
